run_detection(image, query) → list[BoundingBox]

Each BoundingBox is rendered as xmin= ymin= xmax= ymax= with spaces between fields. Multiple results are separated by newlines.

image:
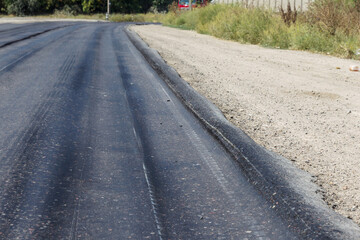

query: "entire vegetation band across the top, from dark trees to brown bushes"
xmin=0 ymin=0 xmax=360 ymax=59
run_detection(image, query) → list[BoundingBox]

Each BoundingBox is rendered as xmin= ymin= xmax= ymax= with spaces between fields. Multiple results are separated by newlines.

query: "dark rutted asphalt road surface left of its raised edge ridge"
xmin=0 ymin=23 xmax=297 ymax=240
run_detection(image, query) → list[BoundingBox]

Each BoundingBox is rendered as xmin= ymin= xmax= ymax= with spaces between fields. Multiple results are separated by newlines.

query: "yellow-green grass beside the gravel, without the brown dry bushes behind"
xmin=161 ymin=4 xmax=360 ymax=59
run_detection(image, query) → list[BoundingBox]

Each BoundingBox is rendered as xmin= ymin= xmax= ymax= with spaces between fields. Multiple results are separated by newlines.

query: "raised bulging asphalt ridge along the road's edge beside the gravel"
xmin=126 ymin=25 xmax=360 ymax=239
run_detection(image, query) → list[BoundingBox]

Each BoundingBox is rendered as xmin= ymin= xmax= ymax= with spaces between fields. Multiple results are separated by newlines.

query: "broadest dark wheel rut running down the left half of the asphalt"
xmin=25 ymin=24 xmax=102 ymax=239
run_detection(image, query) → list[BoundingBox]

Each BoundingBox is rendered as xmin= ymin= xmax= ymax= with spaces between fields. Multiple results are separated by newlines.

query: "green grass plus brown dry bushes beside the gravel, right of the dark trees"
xmin=161 ymin=0 xmax=360 ymax=59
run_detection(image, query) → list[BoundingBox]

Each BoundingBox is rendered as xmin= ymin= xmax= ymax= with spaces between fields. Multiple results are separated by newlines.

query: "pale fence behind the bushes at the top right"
xmin=212 ymin=0 xmax=311 ymax=11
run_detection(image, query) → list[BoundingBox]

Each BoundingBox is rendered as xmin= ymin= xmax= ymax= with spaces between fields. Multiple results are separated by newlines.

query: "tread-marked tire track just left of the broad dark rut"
xmin=0 ymin=54 xmax=76 ymax=236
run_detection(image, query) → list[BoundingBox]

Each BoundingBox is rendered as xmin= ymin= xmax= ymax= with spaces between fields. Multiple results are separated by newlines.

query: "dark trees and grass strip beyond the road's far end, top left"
xmin=0 ymin=0 xmax=169 ymax=22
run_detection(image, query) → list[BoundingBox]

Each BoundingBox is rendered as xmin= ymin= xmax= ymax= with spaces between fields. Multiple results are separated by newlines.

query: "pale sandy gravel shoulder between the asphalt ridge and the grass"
xmin=132 ymin=25 xmax=360 ymax=224
